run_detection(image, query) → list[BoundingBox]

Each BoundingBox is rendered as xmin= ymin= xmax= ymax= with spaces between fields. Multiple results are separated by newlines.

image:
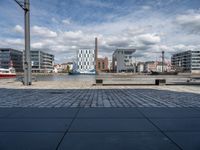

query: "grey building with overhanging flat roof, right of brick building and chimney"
xmin=112 ymin=49 xmax=136 ymax=72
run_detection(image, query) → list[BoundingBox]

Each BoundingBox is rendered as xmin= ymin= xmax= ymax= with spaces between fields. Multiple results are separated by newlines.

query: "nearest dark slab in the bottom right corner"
xmin=166 ymin=132 xmax=200 ymax=150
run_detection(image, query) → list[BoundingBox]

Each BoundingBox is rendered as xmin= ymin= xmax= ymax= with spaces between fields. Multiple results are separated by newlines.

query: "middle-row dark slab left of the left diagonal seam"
xmin=0 ymin=119 xmax=72 ymax=132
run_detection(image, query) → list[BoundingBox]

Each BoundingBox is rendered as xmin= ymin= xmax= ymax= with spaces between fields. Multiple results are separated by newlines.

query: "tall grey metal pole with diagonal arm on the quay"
xmin=14 ymin=0 xmax=32 ymax=86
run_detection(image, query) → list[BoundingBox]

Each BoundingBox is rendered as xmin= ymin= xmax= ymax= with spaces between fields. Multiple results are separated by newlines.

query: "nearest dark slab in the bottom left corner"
xmin=0 ymin=132 xmax=63 ymax=150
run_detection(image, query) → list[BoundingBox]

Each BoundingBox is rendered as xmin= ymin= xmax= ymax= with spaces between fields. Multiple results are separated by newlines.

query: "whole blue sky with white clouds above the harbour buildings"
xmin=0 ymin=0 xmax=200 ymax=63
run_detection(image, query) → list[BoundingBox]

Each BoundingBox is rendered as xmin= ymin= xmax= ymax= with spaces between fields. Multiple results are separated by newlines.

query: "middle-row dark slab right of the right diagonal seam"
xmin=151 ymin=118 xmax=200 ymax=131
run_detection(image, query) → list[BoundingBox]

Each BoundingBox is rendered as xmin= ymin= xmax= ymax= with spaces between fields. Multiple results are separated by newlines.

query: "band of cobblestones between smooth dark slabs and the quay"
xmin=0 ymin=86 xmax=200 ymax=107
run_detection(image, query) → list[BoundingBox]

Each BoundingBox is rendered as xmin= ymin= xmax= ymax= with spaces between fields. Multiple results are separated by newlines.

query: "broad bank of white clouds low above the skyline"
xmin=3 ymin=7 xmax=200 ymax=62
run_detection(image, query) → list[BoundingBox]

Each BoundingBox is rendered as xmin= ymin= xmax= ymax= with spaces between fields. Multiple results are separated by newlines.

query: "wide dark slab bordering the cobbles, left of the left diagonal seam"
xmin=9 ymin=108 xmax=78 ymax=118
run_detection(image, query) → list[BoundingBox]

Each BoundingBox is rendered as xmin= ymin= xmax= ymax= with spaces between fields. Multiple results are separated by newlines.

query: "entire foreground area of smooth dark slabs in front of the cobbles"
xmin=0 ymin=107 xmax=200 ymax=150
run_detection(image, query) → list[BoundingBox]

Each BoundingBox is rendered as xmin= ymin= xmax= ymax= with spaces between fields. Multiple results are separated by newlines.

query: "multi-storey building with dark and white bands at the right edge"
xmin=171 ymin=50 xmax=200 ymax=73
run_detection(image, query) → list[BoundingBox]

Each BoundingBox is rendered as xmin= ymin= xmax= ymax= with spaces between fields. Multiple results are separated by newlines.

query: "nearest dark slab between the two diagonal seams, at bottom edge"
xmin=59 ymin=132 xmax=179 ymax=150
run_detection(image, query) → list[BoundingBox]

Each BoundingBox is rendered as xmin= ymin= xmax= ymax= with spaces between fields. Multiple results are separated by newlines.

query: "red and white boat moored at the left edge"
xmin=0 ymin=68 xmax=16 ymax=78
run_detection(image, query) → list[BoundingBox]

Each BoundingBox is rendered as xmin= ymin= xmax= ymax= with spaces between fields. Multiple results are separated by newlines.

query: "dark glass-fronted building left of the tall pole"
xmin=0 ymin=48 xmax=23 ymax=72
